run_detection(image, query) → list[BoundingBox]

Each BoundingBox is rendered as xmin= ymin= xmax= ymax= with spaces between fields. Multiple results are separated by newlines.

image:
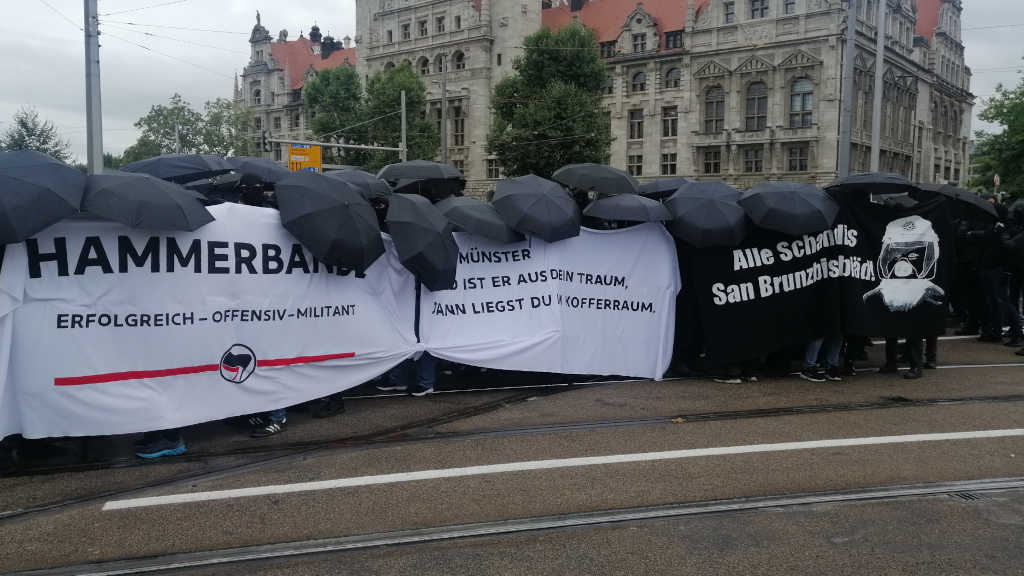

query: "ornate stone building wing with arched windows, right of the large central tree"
xmin=542 ymin=0 xmax=973 ymax=187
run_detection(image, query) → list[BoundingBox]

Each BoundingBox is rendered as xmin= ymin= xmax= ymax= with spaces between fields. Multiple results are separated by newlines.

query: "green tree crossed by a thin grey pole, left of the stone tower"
xmin=364 ymin=64 xmax=440 ymax=171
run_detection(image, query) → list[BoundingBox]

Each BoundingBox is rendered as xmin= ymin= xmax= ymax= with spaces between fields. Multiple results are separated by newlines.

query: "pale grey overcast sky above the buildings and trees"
xmin=0 ymin=0 xmax=1024 ymax=159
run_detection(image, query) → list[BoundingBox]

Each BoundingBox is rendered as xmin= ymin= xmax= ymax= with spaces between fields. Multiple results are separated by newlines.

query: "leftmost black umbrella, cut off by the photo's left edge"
xmin=0 ymin=150 xmax=85 ymax=244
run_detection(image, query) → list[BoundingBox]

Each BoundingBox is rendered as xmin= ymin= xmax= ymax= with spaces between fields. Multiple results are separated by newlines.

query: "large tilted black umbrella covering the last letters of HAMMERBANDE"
xmin=275 ymin=172 xmax=384 ymax=273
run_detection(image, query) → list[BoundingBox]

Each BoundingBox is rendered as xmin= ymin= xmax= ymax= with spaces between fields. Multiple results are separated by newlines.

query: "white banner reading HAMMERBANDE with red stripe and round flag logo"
xmin=0 ymin=204 xmax=422 ymax=438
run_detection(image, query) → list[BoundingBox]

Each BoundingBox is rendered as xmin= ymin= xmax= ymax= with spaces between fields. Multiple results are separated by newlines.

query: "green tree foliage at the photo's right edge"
xmin=971 ymin=70 xmax=1024 ymax=196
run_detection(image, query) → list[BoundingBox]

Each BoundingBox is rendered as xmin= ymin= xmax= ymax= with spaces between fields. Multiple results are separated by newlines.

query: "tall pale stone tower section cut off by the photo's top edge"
xmin=355 ymin=0 xmax=541 ymax=191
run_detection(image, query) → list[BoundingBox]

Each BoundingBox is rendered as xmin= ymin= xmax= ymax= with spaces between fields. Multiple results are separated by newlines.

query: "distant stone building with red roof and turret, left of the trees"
xmin=234 ymin=12 xmax=356 ymax=164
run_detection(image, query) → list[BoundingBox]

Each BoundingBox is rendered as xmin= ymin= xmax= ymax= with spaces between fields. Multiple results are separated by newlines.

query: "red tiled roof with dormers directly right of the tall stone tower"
xmin=541 ymin=0 xmax=708 ymax=42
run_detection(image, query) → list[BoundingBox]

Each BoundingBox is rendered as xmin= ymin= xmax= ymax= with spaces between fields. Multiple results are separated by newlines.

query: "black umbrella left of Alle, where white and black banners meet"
xmin=665 ymin=182 xmax=749 ymax=248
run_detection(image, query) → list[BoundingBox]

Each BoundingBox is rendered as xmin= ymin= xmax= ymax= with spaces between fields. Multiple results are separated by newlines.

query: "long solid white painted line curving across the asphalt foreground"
xmin=102 ymin=428 xmax=1024 ymax=510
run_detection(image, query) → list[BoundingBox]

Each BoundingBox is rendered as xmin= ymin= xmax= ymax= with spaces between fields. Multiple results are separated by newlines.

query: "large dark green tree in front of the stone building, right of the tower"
xmin=487 ymin=25 xmax=611 ymax=177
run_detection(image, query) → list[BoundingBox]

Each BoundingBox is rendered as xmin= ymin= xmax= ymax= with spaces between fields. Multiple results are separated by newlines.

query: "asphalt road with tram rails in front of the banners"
xmin=0 ymin=340 xmax=1024 ymax=574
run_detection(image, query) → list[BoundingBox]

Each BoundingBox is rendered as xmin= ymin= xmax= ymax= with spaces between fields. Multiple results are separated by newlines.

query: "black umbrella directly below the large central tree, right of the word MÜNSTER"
xmin=490 ymin=174 xmax=580 ymax=242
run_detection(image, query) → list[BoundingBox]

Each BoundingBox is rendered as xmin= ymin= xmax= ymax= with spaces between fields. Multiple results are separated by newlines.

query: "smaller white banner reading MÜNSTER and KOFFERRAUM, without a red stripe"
xmin=420 ymin=223 xmax=680 ymax=378
